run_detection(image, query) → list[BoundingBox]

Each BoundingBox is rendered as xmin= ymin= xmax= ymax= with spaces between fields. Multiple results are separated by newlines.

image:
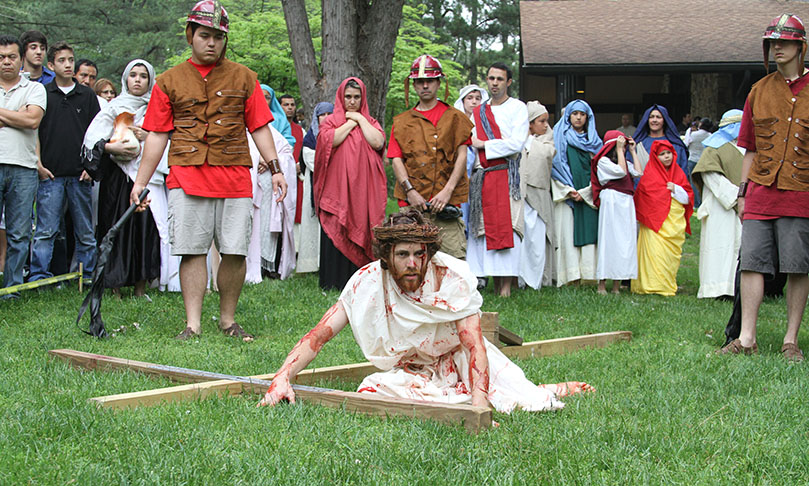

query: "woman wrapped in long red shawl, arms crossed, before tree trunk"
xmin=314 ymin=77 xmax=387 ymax=290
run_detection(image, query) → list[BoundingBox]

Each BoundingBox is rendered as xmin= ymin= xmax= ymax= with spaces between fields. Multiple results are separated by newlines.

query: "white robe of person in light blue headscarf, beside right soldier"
xmin=697 ymin=172 xmax=742 ymax=299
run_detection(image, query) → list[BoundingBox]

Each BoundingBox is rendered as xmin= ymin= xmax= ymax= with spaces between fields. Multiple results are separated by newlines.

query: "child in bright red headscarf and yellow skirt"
xmin=632 ymin=140 xmax=694 ymax=295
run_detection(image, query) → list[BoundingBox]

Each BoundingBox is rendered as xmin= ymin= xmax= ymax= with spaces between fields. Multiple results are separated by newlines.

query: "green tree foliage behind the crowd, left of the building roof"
xmin=0 ymin=0 xmax=519 ymax=117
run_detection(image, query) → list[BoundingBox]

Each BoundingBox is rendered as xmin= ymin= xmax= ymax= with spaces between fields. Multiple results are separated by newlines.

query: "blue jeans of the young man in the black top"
xmin=29 ymin=176 xmax=96 ymax=280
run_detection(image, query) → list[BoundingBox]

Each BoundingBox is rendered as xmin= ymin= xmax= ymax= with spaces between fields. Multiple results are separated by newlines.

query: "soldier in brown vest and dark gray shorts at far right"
xmin=718 ymin=14 xmax=809 ymax=361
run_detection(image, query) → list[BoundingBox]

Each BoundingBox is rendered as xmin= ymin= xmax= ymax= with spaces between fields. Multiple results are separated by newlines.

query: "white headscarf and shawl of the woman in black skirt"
xmin=84 ymin=59 xmax=155 ymax=150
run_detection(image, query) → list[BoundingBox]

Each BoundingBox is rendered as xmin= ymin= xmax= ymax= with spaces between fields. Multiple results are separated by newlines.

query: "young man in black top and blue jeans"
xmin=30 ymin=42 xmax=99 ymax=280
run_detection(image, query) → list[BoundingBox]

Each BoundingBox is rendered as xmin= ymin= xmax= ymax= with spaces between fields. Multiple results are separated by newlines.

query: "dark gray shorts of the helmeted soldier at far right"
xmin=739 ymin=217 xmax=809 ymax=276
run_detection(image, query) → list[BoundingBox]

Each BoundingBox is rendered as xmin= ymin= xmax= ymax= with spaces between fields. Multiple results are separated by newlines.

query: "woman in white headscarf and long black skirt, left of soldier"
xmin=84 ymin=59 xmax=169 ymax=296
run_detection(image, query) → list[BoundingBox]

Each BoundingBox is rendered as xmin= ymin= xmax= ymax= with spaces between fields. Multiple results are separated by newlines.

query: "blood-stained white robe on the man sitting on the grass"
xmin=340 ymin=252 xmax=564 ymax=413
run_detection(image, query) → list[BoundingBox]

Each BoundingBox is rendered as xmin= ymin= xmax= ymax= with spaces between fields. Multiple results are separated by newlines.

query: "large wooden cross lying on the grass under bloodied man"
xmin=49 ymin=312 xmax=632 ymax=432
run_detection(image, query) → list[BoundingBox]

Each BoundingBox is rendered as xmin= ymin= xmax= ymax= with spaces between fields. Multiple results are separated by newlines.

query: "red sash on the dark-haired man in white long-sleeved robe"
xmin=474 ymin=104 xmax=514 ymax=250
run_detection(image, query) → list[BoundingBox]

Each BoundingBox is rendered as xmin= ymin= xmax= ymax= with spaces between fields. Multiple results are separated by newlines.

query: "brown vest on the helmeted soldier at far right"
xmin=747 ymin=71 xmax=809 ymax=191
